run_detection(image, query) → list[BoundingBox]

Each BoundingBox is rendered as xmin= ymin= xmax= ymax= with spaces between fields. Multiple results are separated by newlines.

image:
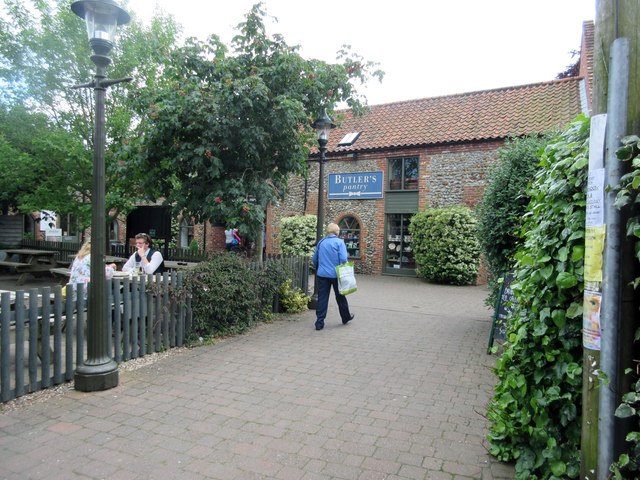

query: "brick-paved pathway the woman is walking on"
xmin=0 ymin=276 xmax=513 ymax=480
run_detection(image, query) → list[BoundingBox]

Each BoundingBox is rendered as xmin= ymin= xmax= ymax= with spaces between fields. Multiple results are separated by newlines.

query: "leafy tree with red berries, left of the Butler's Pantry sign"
xmin=123 ymin=4 xmax=382 ymax=244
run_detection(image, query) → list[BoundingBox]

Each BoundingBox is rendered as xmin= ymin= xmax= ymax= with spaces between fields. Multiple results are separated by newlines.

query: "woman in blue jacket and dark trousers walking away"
xmin=313 ymin=223 xmax=354 ymax=330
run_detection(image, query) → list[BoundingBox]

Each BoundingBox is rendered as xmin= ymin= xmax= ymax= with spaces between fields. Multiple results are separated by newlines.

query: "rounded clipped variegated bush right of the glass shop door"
xmin=409 ymin=207 xmax=480 ymax=285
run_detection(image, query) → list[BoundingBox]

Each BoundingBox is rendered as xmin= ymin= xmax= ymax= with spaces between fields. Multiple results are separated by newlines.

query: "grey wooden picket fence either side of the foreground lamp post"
xmin=0 ymin=272 xmax=192 ymax=402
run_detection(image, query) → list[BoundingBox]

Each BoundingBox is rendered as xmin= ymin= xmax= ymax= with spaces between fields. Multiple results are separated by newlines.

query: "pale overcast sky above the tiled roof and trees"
xmin=127 ymin=0 xmax=595 ymax=105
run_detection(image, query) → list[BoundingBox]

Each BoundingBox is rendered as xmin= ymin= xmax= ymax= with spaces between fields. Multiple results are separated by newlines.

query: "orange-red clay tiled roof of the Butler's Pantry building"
xmin=328 ymin=77 xmax=582 ymax=152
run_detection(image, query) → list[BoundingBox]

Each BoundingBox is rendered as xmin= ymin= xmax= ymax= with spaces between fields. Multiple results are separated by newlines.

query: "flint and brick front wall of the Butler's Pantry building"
xmin=267 ymin=141 xmax=504 ymax=281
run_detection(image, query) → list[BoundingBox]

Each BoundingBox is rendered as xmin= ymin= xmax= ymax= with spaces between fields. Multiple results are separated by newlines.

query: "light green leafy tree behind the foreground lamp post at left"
xmin=0 ymin=0 xmax=179 ymax=223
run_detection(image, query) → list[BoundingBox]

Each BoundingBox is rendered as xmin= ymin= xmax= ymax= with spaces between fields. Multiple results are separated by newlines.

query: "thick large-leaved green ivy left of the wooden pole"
xmin=488 ymin=117 xmax=589 ymax=480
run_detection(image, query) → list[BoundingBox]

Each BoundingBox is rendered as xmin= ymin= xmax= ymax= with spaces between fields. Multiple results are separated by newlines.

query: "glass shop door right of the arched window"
xmin=384 ymin=213 xmax=416 ymax=275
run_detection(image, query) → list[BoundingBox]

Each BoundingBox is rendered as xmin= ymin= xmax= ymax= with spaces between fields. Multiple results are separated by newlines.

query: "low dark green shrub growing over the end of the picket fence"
xmin=185 ymin=253 xmax=271 ymax=337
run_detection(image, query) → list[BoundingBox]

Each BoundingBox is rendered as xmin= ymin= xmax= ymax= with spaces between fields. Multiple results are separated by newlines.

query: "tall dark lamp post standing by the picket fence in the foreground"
xmin=71 ymin=0 xmax=131 ymax=392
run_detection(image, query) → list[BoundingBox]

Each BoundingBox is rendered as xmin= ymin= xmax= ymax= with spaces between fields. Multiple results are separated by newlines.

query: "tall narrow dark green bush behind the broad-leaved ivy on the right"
xmin=476 ymin=136 xmax=547 ymax=305
